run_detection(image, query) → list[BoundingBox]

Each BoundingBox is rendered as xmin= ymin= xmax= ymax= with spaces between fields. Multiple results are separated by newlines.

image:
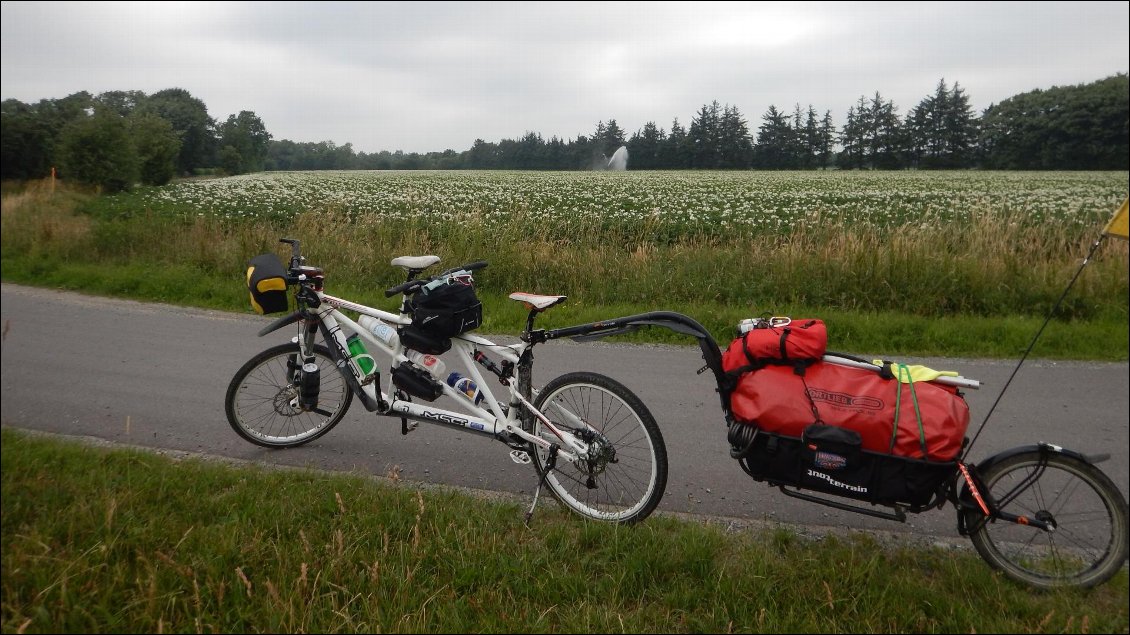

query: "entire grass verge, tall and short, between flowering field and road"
xmin=0 ymin=178 xmax=1130 ymax=360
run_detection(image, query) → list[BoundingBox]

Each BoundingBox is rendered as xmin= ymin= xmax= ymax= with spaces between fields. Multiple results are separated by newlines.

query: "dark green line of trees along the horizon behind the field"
xmin=0 ymin=73 xmax=1130 ymax=191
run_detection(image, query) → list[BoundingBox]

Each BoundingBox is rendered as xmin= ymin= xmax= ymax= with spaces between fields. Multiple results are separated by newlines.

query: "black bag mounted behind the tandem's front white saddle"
xmin=401 ymin=271 xmax=483 ymax=355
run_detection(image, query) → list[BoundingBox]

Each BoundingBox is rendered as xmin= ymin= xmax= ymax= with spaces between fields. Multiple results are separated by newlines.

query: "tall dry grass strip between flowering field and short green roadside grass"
xmin=2 ymin=175 xmax=1130 ymax=358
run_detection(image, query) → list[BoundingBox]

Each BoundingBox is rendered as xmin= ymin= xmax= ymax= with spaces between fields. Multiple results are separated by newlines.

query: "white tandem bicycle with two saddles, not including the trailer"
xmin=225 ymin=238 xmax=668 ymax=523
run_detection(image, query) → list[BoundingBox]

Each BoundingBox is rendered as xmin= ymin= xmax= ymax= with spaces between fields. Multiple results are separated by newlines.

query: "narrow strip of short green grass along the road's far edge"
xmin=0 ymin=246 xmax=1130 ymax=362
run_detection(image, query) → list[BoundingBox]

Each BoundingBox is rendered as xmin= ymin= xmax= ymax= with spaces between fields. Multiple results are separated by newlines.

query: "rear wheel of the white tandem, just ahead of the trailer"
xmin=531 ymin=373 xmax=667 ymax=523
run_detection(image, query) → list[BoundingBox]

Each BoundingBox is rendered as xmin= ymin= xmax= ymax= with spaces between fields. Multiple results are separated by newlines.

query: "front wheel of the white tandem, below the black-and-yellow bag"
xmin=224 ymin=342 xmax=353 ymax=447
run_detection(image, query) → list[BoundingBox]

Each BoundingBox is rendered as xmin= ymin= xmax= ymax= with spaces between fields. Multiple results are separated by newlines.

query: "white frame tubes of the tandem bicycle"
xmin=297 ymin=292 xmax=592 ymax=461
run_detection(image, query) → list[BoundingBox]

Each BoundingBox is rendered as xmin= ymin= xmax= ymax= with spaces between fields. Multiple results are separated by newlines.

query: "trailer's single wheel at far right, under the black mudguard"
xmin=965 ymin=450 xmax=1127 ymax=589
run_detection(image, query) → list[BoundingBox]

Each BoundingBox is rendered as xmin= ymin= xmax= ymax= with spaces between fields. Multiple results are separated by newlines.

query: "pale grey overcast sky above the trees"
xmin=0 ymin=1 xmax=1130 ymax=153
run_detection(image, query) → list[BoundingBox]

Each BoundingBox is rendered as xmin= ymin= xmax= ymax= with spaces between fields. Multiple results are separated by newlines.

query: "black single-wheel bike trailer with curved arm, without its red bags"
xmin=558 ymin=312 xmax=1130 ymax=589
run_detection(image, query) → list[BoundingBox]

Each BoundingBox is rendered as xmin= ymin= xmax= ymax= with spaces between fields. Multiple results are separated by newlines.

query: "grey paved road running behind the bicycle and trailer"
xmin=0 ymin=284 xmax=1130 ymax=537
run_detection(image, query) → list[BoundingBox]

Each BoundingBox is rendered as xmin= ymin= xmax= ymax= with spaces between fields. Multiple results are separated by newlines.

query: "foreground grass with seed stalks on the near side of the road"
xmin=0 ymin=428 xmax=1128 ymax=633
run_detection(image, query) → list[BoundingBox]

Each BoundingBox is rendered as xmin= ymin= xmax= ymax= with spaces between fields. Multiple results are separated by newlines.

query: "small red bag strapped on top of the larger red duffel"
xmin=722 ymin=320 xmax=828 ymax=375
